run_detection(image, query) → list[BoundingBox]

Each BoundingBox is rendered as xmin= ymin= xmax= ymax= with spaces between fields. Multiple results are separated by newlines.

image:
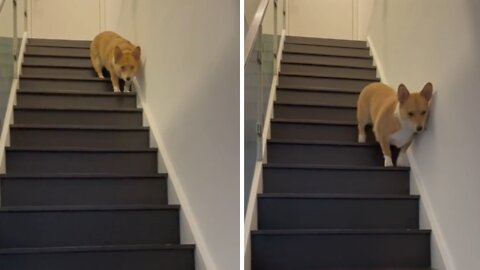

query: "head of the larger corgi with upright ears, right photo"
xmin=397 ymin=83 xmax=433 ymax=132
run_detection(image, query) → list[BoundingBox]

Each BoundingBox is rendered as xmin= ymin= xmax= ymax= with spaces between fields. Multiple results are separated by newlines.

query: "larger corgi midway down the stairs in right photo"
xmin=357 ymin=83 xmax=433 ymax=167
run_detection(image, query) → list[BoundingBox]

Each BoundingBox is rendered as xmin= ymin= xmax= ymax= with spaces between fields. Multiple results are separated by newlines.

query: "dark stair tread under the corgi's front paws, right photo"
xmin=263 ymin=163 xmax=410 ymax=172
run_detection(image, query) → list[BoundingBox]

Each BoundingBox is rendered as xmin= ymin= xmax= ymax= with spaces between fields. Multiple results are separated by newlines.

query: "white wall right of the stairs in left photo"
xmin=106 ymin=0 xmax=240 ymax=270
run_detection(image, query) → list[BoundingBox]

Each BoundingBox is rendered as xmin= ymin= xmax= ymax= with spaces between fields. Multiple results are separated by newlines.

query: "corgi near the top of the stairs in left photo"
xmin=90 ymin=31 xmax=140 ymax=92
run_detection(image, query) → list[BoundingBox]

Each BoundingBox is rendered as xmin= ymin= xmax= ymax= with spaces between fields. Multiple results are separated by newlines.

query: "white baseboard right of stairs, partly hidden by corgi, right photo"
xmin=367 ymin=36 xmax=457 ymax=270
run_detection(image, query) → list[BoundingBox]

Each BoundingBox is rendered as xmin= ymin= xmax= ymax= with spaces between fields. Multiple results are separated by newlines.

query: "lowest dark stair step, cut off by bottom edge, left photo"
xmin=0 ymin=245 xmax=195 ymax=270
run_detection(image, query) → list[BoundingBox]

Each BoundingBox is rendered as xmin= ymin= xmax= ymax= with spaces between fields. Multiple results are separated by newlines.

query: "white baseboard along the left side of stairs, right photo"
xmin=243 ymin=29 xmax=285 ymax=270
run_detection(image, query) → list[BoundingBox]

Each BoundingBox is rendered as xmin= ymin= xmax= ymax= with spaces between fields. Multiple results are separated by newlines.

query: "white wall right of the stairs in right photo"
xmin=369 ymin=0 xmax=480 ymax=270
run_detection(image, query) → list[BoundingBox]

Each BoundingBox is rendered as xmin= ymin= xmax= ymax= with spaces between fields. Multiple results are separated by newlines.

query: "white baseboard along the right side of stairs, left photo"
xmin=133 ymin=79 xmax=218 ymax=270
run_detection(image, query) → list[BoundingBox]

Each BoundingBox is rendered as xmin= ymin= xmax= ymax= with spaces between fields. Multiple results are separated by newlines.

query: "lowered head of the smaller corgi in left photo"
xmin=114 ymin=46 xmax=140 ymax=81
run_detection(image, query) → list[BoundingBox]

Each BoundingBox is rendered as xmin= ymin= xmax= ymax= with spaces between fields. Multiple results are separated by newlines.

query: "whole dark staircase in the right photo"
xmin=252 ymin=37 xmax=430 ymax=270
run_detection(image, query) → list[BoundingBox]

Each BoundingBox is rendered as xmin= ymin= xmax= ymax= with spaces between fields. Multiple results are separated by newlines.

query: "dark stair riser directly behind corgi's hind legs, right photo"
xmin=270 ymin=118 xmax=375 ymax=143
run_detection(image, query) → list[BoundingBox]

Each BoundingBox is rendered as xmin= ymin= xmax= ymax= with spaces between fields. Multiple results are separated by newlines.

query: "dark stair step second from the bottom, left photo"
xmin=0 ymin=205 xmax=180 ymax=248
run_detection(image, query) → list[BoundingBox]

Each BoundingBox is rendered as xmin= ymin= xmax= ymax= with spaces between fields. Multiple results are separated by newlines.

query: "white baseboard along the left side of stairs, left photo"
xmin=0 ymin=32 xmax=27 ymax=173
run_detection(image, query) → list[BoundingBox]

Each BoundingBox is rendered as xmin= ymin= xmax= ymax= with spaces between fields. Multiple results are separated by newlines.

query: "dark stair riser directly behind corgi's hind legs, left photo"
xmin=22 ymin=65 xmax=97 ymax=78
